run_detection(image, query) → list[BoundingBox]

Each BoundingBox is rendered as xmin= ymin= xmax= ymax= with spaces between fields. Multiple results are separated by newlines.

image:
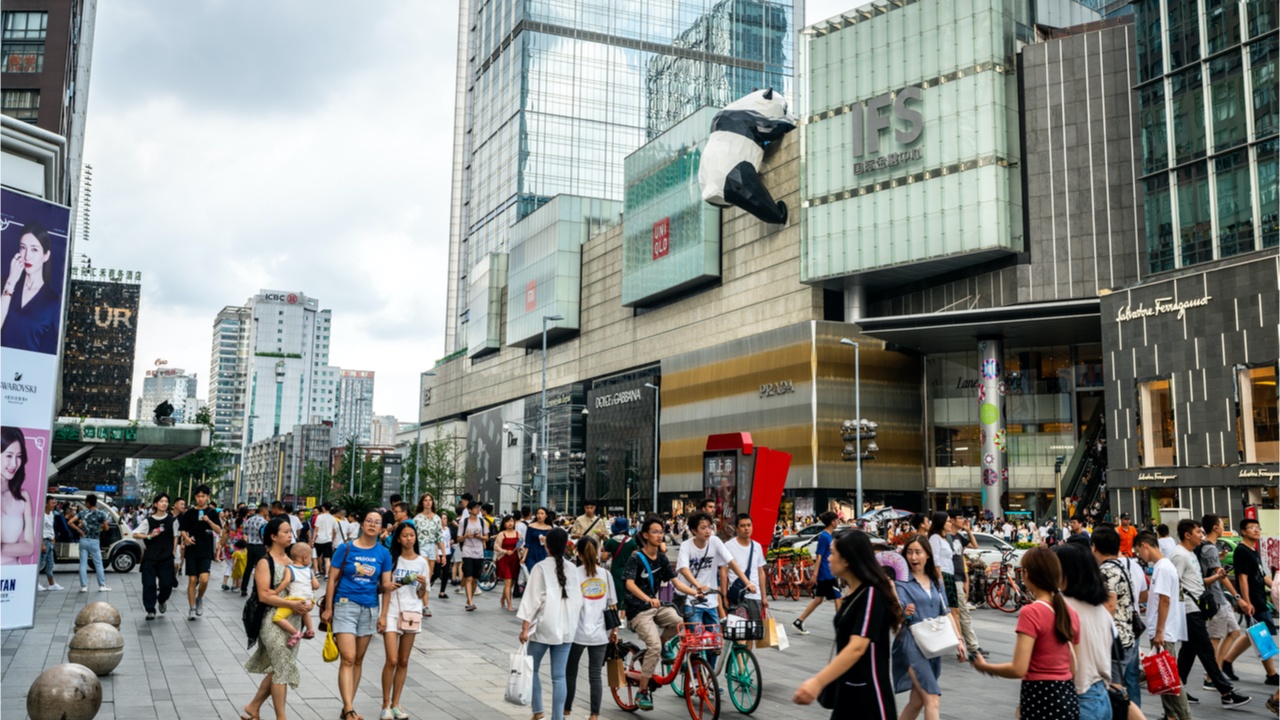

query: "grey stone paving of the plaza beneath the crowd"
xmin=0 ymin=570 xmax=1270 ymax=720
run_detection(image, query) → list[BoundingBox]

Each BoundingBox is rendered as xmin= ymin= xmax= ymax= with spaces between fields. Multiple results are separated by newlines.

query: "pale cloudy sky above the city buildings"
xmin=87 ymin=0 xmax=861 ymax=420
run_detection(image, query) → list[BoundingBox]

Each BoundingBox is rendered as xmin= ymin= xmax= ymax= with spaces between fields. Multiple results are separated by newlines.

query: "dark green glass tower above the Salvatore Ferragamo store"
xmin=1135 ymin=0 xmax=1280 ymax=273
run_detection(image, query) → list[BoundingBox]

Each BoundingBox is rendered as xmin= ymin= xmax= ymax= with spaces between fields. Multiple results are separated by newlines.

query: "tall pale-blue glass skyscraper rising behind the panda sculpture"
xmin=445 ymin=0 xmax=804 ymax=352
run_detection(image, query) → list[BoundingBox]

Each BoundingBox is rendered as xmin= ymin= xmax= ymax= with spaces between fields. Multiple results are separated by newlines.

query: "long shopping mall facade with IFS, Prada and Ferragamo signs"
xmin=422 ymin=0 xmax=1280 ymax=516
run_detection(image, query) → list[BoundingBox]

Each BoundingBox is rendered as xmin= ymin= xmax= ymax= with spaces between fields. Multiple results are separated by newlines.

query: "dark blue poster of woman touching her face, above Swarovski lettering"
xmin=0 ymin=192 xmax=69 ymax=355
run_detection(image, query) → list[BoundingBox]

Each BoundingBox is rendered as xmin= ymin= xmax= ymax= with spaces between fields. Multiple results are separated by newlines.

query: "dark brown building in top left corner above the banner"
xmin=0 ymin=0 xmax=97 ymax=221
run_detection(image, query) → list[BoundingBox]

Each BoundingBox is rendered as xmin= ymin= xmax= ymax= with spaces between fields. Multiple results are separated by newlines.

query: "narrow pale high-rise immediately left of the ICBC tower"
xmin=209 ymin=305 xmax=253 ymax=465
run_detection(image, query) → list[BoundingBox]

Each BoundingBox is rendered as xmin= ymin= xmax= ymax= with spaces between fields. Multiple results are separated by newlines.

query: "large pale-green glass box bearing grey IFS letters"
xmin=800 ymin=0 xmax=1021 ymax=282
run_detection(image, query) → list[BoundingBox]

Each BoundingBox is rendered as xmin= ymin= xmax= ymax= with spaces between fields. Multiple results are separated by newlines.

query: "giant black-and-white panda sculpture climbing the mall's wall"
xmin=698 ymin=87 xmax=796 ymax=224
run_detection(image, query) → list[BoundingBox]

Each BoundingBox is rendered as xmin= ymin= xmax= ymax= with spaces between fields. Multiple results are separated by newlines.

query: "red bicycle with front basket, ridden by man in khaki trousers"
xmin=609 ymin=623 xmax=724 ymax=720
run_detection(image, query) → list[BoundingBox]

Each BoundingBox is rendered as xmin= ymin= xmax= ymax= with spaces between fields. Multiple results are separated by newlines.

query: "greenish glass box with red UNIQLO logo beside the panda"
xmin=622 ymin=108 xmax=721 ymax=307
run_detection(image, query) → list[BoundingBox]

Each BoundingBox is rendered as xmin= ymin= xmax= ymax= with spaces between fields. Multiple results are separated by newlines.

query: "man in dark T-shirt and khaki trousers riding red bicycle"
xmin=623 ymin=515 xmax=700 ymax=711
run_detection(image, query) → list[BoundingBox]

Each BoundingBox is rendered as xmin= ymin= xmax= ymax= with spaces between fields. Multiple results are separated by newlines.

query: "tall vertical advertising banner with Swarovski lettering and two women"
xmin=0 ymin=190 xmax=70 ymax=630
